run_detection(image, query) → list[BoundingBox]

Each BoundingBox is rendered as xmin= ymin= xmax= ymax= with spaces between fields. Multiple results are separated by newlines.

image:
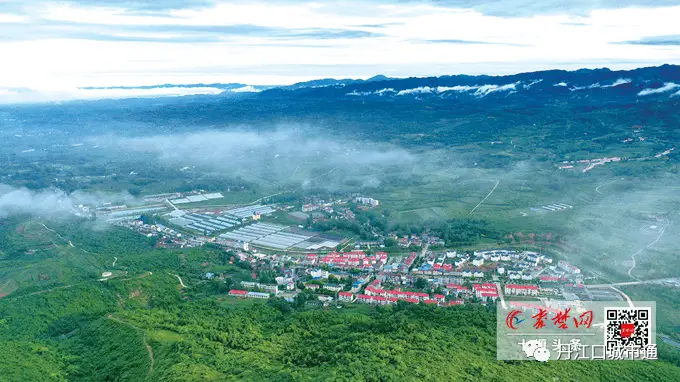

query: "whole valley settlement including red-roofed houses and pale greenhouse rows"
xmin=106 ymin=194 xmax=624 ymax=314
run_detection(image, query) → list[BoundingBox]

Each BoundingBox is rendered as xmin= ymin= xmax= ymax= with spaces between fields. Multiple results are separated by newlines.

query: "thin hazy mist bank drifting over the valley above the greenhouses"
xmin=115 ymin=126 xmax=417 ymax=187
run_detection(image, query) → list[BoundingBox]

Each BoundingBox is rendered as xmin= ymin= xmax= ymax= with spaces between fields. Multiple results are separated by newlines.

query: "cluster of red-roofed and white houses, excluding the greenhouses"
xmin=218 ymin=247 xmax=600 ymax=306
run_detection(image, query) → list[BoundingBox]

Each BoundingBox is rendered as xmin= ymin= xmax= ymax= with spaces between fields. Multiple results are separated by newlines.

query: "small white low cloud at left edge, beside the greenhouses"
xmin=0 ymin=183 xmax=134 ymax=218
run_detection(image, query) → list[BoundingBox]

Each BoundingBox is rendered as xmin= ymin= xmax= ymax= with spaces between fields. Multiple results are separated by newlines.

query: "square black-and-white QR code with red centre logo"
xmin=604 ymin=308 xmax=651 ymax=350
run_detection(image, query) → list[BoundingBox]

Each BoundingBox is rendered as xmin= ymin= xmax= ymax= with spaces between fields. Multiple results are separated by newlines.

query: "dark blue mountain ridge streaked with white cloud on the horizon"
xmin=260 ymin=65 xmax=680 ymax=103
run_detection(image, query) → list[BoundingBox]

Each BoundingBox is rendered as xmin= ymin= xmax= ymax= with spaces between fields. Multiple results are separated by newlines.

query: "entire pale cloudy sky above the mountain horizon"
xmin=0 ymin=0 xmax=680 ymax=98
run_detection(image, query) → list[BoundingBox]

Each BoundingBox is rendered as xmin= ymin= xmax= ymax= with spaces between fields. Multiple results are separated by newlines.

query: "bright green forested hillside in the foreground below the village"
xmin=0 ymin=284 xmax=680 ymax=382
